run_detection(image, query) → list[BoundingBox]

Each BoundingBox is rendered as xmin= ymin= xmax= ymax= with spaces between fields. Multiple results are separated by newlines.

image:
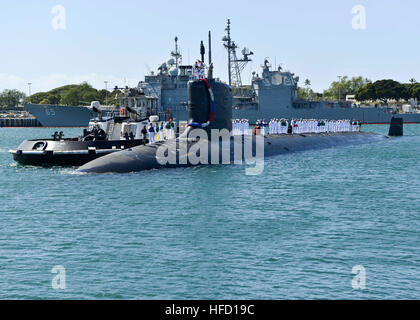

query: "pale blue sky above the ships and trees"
xmin=0 ymin=0 xmax=420 ymax=93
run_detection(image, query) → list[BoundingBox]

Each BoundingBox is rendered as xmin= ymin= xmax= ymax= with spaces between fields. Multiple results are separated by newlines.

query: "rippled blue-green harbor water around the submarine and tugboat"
xmin=0 ymin=125 xmax=420 ymax=299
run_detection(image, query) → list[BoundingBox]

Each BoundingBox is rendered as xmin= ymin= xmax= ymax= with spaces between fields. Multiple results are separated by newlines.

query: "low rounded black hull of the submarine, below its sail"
xmin=78 ymin=132 xmax=386 ymax=173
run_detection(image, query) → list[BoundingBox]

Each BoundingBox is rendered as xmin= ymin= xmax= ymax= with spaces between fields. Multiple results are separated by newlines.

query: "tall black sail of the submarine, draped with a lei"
xmin=187 ymin=79 xmax=232 ymax=137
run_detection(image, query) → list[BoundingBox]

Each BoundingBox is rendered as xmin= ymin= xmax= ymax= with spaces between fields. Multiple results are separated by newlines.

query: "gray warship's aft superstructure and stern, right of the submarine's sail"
xmin=233 ymin=60 xmax=420 ymax=124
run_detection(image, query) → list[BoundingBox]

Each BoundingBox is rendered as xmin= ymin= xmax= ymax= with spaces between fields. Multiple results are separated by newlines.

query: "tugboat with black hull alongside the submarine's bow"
xmin=9 ymin=87 xmax=175 ymax=166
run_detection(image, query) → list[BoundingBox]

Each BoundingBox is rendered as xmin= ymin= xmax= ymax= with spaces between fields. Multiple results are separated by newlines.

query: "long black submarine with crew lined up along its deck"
xmin=78 ymin=68 xmax=402 ymax=173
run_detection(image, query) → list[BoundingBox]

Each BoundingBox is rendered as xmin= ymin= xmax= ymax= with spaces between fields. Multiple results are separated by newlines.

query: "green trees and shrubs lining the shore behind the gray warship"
xmin=0 ymin=76 xmax=420 ymax=111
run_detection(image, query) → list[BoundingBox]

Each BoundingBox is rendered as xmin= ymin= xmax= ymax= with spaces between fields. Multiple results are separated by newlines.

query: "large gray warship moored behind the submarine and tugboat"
xmin=25 ymin=20 xmax=420 ymax=127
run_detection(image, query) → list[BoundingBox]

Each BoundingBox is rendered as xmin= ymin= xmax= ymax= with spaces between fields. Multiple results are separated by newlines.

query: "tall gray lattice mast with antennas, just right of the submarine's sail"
xmin=222 ymin=19 xmax=254 ymax=87
